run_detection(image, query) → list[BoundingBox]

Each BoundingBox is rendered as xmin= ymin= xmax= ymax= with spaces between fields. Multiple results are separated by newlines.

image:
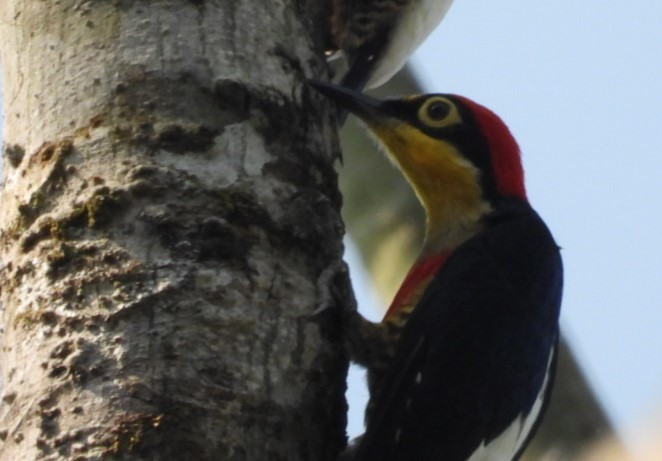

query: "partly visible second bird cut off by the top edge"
xmin=331 ymin=0 xmax=453 ymax=90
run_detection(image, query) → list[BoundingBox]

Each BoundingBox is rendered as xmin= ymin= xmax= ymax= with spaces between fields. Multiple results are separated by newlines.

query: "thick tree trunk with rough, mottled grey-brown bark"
xmin=0 ymin=0 xmax=349 ymax=461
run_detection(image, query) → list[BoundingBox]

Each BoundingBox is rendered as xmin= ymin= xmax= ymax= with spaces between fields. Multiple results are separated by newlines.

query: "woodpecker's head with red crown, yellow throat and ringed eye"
xmin=311 ymin=81 xmax=526 ymax=247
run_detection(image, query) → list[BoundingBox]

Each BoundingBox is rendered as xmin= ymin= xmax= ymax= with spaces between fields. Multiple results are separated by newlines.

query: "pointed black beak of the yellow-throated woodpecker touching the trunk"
xmin=307 ymin=80 xmax=388 ymax=126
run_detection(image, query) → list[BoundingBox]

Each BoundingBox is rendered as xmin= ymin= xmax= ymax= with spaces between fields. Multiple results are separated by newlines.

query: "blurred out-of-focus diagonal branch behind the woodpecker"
xmin=341 ymin=70 xmax=613 ymax=461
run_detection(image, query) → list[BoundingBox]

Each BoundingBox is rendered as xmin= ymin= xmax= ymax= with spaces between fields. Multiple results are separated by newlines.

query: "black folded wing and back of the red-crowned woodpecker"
xmin=356 ymin=204 xmax=562 ymax=461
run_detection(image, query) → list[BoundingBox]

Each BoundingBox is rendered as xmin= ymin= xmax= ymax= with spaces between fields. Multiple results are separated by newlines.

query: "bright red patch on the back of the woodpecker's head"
xmin=455 ymin=96 xmax=526 ymax=199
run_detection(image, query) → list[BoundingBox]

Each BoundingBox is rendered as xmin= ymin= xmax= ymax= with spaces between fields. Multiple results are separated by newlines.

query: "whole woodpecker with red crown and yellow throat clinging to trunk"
xmin=312 ymin=82 xmax=563 ymax=461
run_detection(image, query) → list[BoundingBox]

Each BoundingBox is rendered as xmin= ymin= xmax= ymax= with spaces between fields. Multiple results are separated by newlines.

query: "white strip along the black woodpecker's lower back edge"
xmin=467 ymin=349 xmax=554 ymax=461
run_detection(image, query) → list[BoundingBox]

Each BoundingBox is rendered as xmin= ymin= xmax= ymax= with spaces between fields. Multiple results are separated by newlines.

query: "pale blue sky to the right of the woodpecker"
xmin=348 ymin=0 xmax=662 ymax=452
